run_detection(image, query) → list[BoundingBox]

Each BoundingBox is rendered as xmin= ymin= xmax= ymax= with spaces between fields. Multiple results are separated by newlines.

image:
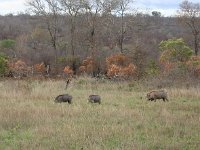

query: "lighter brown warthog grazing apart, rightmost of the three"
xmin=147 ymin=90 xmax=168 ymax=102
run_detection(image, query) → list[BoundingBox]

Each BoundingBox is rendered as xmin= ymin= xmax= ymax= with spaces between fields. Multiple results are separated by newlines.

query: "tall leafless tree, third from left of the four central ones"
xmin=84 ymin=0 xmax=117 ymax=57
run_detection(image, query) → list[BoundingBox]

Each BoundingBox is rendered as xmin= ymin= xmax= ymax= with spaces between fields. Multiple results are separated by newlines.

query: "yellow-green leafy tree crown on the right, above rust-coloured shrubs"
xmin=159 ymin=38 xmax=193 ymax=62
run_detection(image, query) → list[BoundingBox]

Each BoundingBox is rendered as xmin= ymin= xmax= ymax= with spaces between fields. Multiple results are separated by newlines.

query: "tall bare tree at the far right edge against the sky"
xmin=178 ymin=0 xmax=200 ymax=55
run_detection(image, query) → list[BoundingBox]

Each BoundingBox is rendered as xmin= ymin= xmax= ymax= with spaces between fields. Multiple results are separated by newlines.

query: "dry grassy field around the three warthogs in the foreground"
xmin=0 ymin=78 xmax=200 ymax=150
